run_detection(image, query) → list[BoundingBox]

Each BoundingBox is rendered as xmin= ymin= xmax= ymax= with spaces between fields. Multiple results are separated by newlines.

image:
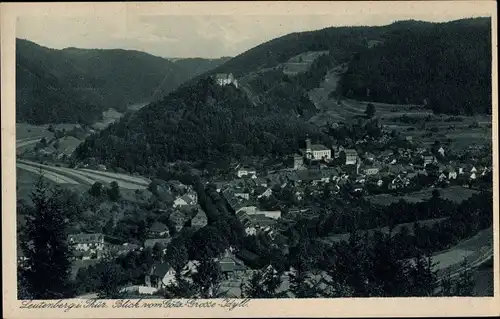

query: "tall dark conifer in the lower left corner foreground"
xmin=19 ymin=172 xmax=72 ymax=299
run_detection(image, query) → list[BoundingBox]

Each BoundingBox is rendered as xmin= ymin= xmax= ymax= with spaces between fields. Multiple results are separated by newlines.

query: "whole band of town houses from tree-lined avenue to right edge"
xmin=214 ymin=139 xmax=491 ymax=220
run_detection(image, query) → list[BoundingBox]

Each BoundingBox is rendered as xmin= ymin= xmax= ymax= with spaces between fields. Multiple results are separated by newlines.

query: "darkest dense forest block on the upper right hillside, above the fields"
xmin=340 ymin=18 xmax=491 ymax=115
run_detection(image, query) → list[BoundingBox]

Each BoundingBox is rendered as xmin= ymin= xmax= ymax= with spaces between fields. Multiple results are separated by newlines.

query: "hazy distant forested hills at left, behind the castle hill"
xmin=16 ymin=39 xmax=227 ymax=124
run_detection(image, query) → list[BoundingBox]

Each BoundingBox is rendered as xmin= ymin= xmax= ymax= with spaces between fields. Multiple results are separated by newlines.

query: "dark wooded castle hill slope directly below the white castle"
xmin=75 ymin=77 xmax=322 ymax=175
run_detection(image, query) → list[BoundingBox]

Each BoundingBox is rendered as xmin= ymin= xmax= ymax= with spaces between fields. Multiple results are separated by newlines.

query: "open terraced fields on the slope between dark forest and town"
xmin=309 ymin=66 xmax=492 ymax=151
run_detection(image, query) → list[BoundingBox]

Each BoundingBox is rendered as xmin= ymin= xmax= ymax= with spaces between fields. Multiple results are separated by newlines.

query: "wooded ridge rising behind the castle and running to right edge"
xmin=185 ymin=18 xmax=491 ymax=114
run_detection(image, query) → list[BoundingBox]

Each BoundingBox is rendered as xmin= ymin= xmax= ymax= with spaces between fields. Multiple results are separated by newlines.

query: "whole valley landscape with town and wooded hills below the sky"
xmin=16 ymin=13 xmax=497 ymax=307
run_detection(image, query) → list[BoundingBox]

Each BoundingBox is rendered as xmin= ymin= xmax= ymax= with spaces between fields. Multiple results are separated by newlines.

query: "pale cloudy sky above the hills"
xmin=16 ymin=2 xmax=492 ymax=58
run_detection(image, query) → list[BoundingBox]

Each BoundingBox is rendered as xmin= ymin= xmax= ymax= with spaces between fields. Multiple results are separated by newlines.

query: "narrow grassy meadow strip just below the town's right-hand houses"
xmin=366 ymin=186 xmax=478 ymax=205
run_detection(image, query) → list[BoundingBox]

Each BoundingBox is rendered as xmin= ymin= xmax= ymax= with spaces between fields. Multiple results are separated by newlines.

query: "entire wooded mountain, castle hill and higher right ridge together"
xmin=77 ymin=19 xmax=491 ymax=173
